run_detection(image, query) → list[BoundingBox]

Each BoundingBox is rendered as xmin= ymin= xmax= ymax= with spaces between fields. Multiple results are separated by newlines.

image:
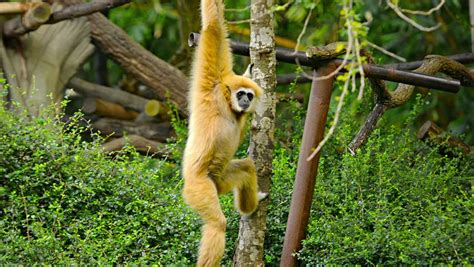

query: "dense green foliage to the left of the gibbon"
xmin=0 ymin=101 xmax=200 ymax=265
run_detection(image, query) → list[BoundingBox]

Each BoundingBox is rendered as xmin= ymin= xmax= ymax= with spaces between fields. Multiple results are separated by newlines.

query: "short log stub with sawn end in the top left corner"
xmin=3 ymin=3 xmax=52 ymax=36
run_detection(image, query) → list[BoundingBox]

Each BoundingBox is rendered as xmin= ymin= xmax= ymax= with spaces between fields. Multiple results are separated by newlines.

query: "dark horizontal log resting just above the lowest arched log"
xmin=92 ymin=118 xmax=174 ymax=142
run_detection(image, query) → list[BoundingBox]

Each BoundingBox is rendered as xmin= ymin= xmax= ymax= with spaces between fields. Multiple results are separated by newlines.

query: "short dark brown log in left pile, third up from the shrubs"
xmin=82 ymin=98 xmax=139 ymax=120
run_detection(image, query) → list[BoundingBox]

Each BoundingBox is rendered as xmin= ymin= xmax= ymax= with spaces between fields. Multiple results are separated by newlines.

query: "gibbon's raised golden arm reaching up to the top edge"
xmin=194 ymin=0 xmax=233 ymax=86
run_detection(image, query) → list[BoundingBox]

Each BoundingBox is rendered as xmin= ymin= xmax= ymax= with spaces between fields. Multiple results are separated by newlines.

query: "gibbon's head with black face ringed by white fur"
xmin=224 ymin=65 xmax=263 ymax=113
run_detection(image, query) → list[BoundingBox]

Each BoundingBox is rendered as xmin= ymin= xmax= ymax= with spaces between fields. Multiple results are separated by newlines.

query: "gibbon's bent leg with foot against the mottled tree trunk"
xmin=216 ymin=158 xmax=266 ymax=215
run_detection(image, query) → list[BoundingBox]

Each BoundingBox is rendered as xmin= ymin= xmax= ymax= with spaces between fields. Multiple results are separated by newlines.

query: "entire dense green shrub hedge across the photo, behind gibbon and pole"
xmin=0 ymin=94 xmax=474 ymax=265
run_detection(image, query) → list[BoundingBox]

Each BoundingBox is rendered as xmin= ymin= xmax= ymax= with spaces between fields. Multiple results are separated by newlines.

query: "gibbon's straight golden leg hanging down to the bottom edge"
xmin=183 ymin=175 xmax=226 ymax=266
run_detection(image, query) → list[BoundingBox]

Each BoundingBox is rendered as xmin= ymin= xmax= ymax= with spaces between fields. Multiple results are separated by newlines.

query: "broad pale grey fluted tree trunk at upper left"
xmin=0 ymin=2 xmax=94 ymax=116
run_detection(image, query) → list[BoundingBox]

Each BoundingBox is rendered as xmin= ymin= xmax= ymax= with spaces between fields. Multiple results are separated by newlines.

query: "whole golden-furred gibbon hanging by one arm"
xmin=183 ymin=0 xmax=266 ymax=266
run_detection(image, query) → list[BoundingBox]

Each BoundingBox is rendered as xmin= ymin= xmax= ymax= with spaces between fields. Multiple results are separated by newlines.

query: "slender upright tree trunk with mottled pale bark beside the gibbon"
xmin=234 ymin=0 xmax=276 ymax=266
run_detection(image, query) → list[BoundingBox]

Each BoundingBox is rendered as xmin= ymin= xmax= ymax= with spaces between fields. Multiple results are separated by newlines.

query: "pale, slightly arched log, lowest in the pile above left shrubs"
xmin=102 ymin=134 xmax=171 ymax=157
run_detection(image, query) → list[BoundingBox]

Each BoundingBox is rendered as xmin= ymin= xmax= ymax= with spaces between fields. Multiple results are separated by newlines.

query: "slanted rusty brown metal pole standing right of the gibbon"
xmin=280 ymin=62 xmax=337 ymax=267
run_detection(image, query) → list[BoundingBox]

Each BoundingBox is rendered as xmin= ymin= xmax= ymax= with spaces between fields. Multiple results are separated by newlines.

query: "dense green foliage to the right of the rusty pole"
xmin=298 ymin=97 xmax=474 ymax=265
